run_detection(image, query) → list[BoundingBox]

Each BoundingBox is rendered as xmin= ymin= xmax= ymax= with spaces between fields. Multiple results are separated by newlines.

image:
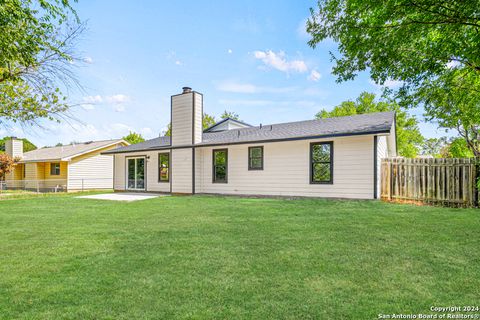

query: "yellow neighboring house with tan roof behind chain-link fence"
xmin=5 ymin=137 xmax=129 ymax=191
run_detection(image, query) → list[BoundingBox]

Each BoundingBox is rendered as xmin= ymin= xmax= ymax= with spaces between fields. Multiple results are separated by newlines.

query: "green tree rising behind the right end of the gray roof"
xmin=315 ymin=92 xmax=424 ymax=157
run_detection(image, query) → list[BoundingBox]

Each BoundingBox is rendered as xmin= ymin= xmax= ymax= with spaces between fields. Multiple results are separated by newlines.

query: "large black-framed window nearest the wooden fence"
xmin=310 ymin=142 xmax=333 ymax=183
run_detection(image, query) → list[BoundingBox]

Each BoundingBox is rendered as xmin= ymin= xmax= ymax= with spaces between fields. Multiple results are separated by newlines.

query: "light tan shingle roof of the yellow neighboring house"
xmin=22 ymin=139 xmax=124 ymax=162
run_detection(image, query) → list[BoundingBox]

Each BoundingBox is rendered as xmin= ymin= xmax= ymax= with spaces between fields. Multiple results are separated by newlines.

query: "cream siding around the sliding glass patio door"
xmin=114 ymin=150 xmax=173 ymax=192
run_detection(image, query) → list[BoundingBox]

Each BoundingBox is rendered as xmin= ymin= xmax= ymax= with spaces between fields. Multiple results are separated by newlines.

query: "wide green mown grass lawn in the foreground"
xmin=0 ymin=195 xmax=480 ymax=319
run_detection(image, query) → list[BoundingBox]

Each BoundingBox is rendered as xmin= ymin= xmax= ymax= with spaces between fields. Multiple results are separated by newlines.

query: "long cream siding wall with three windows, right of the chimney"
xmin=197 ymin=135 xmax=373 ymax=199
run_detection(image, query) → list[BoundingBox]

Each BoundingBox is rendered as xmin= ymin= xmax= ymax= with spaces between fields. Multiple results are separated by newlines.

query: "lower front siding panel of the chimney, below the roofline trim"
xmin=171 ymin=148 xmax=193 ymax=193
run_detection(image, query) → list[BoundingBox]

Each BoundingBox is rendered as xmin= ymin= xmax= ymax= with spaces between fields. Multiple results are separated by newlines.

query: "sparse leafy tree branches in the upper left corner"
xmin=0 ymin=0 xmax=84 ymax=126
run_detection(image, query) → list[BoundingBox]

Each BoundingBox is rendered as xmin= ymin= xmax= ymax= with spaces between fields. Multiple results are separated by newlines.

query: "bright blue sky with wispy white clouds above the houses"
xmin=0 ymin=0 xmax=444 ymax=147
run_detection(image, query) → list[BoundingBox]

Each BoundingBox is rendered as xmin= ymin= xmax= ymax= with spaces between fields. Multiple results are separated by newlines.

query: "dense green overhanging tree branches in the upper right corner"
xmin=307 ymin=0 xmax=480 ymax=156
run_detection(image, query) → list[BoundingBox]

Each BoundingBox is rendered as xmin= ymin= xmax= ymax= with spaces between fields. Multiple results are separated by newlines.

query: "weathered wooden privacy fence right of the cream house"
xmin=381 ymin=158 xmax=479 ymax=207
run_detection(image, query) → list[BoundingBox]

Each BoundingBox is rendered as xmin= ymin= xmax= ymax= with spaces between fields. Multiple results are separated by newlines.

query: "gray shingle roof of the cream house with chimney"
xmin=106 ymin=112 xmax=395 ymax=153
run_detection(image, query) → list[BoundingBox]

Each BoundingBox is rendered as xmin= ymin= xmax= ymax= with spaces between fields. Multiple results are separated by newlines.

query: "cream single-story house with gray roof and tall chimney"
xmin=103 ymin=87 xmax=396 ymax=199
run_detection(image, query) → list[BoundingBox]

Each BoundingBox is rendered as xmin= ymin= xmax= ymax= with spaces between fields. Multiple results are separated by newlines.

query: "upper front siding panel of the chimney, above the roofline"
xmin=172 ymin=93 xmax=193 ymax=146
